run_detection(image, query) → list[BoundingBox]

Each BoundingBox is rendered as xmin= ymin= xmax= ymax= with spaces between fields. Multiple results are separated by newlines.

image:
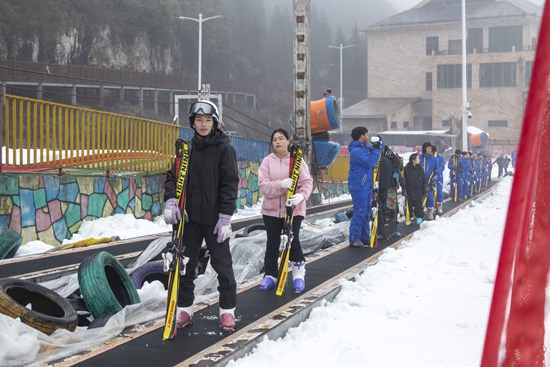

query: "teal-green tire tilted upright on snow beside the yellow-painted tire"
xmin=78 ymin=251 xmax=140 ymax=319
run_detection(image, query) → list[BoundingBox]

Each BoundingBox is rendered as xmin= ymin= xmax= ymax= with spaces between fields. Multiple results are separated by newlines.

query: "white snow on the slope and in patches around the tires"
xmin=0 ymin=177 xmax=549 ymax=367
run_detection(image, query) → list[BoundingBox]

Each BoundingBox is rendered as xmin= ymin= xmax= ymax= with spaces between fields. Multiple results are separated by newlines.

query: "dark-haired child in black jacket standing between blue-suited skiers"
xmin=405 ymin=153 xmax=426 ymax=225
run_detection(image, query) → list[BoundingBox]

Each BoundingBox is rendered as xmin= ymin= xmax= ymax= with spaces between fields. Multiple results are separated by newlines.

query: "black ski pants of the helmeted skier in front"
xmin=178 ymin=222 xmax=237 ymax=309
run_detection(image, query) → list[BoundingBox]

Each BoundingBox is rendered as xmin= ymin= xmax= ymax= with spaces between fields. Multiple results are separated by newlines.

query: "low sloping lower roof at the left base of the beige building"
xmin=342 ymin=98 xmax=421 ymax=118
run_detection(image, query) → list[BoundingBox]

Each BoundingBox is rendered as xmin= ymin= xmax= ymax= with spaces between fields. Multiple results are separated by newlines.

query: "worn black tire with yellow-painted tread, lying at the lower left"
xmin=0 ymin=278 xmax=78 ymax=335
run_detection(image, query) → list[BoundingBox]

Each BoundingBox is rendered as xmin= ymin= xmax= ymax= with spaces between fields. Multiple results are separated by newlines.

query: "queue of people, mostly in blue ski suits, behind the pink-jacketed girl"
xmin=348 ymin=127 xmax=517 ymax=248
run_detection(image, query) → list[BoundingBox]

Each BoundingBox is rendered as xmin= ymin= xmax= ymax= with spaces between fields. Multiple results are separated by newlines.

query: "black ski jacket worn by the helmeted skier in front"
xmin=164 ymin=130 xmax=239 ymax=226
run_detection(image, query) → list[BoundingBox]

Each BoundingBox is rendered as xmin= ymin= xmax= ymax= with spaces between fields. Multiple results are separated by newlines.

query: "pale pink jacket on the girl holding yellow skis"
xmin=258 ymin=153 xmax=313 ymax=218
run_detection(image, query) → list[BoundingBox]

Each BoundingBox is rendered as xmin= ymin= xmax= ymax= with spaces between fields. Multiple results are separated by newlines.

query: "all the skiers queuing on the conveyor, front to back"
xmin=164 ymin=105 xmax=515 ymax=332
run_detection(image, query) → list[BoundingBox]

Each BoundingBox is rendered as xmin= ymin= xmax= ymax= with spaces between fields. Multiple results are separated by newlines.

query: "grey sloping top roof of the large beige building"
xmin=368 ymin=0 xmax=542 ymax=30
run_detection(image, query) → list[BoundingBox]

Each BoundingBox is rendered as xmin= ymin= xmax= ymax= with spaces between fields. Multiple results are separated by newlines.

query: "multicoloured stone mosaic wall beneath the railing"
xmin=0 ymin=161 xmax=347 ymax=245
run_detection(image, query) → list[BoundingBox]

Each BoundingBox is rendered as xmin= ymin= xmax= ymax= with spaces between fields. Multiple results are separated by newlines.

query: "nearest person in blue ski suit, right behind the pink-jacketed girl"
xmin=348 ymin=126 xmax=384 ymax=248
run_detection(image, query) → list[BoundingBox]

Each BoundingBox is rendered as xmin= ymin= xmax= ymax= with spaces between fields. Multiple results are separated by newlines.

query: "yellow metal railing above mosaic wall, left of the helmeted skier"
xmin=0 ymin=94 xmax=180 ymax=172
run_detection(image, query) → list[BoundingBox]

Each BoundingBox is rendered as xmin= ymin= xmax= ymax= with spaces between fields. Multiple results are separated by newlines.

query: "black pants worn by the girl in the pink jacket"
xmin=264 ymin=215 xmax=306 ymax=278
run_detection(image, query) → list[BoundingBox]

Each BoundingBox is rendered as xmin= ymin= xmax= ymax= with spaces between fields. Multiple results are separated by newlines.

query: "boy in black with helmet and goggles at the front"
xmin=164 ymin=100 xmax=239 ymax=331
